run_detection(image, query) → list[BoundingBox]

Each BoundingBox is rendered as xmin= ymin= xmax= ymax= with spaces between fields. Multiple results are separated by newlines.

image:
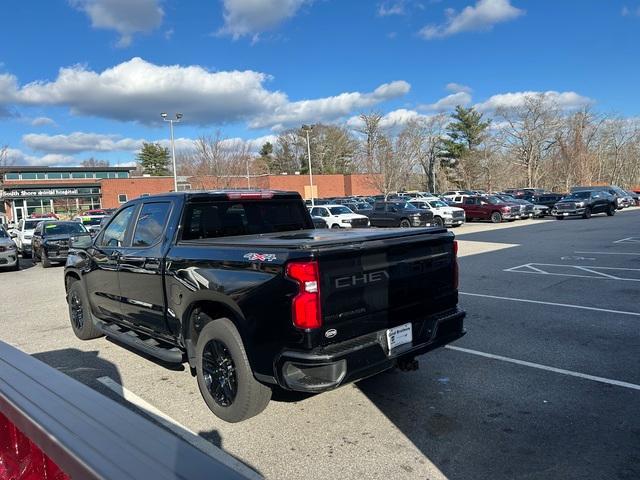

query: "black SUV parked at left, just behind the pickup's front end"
xmin=33 ymin=220 xmax=89 ymax=268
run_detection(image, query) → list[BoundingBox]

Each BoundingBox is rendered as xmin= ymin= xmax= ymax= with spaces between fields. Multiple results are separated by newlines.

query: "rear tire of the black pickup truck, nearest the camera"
xmin=196 ymin=314 xmax=271 ymax=423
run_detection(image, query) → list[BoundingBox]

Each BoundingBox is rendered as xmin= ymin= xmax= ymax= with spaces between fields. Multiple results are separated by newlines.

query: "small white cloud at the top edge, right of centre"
xmin=419 ymin=0 xmax=525 ymax=40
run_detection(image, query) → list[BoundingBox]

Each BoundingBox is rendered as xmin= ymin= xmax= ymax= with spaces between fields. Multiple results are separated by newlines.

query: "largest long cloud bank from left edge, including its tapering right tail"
xmin=0 ymin=57 xmax=410 ymax=129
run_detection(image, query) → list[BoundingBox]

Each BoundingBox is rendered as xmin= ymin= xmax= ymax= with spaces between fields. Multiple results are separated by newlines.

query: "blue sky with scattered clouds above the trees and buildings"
xmin=0 ymin=0 xmax=640 ymax=165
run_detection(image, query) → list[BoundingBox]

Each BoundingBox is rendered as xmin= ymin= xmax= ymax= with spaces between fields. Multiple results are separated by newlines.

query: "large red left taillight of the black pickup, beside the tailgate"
xmin=287 ymin=261 xmax=322 ymax=329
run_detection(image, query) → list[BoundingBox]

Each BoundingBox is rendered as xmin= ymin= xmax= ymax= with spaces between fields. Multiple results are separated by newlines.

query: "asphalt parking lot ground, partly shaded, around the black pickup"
xmin=0 ymin=209 xmax=640 ymax=479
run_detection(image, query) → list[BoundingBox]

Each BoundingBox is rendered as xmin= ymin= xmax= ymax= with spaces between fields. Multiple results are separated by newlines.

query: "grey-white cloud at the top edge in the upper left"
xmin=70 ymin=0 xmax=164 ymax=47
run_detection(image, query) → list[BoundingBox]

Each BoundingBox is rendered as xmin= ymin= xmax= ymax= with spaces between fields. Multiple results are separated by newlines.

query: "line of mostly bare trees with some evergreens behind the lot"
xmin=138 ymin=94 xmax=640 ymax=193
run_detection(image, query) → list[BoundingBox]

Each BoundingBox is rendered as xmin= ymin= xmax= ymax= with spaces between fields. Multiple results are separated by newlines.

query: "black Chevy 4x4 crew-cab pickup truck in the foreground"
xmin=64 ymin=191 xmax=465 ymax=422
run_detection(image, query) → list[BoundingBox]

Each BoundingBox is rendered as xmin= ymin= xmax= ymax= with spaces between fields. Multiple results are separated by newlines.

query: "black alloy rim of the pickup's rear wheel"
xmin=202 ymin=340 xmax=238 ymax=407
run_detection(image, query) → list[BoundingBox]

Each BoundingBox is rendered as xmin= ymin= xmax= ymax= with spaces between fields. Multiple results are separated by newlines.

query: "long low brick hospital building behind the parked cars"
xmin=0 ymin=166 xmax=379 ymax=221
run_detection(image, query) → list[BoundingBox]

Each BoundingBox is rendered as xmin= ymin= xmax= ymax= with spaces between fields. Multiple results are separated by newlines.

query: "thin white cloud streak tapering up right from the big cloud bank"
xmin=249 ymin=80 xmax=411 ymax=130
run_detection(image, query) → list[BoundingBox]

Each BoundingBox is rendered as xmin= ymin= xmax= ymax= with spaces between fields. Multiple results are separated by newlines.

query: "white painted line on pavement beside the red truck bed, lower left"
xmin=97 ymin=377 xmax=262 ymax=479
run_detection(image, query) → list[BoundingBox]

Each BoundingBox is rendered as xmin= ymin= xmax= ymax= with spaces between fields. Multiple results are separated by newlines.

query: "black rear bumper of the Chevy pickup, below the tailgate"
xmin=275 ymin=309 xmax=466 ymax=392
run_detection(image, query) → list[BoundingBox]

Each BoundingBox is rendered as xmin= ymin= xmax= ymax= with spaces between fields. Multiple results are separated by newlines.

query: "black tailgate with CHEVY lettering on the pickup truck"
xmin=317 ymin=231 xmax=458 ymax=344
